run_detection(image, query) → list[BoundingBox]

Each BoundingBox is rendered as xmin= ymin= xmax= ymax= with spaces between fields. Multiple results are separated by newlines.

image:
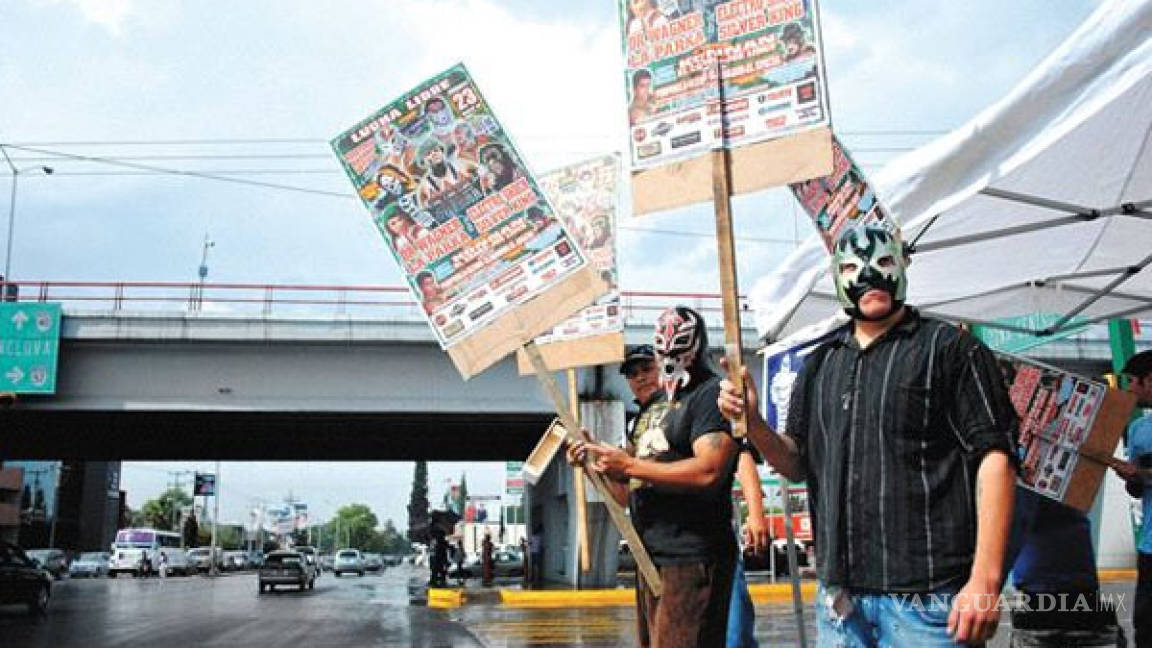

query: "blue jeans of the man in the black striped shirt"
xmin=816 ymin=583 xmax=976 ymax=648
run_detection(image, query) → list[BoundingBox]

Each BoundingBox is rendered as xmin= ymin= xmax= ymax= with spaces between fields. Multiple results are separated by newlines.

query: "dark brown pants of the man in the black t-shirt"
xmin=636 ymin=556 xmax=736 ymax=648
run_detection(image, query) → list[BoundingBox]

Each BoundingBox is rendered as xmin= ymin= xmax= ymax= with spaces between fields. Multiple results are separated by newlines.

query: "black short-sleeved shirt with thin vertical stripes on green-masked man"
xmin=786 ymin=308 xmax=1016 ymax=592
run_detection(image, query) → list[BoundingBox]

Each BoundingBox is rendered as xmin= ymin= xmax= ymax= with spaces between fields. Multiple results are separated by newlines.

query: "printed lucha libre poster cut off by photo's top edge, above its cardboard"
xmin=617 ymin=0 xmax=831 ymax=169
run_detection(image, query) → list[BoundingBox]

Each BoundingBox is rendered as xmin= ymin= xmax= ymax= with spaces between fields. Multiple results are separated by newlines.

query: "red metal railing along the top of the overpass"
xmin=0 ymin=280 xmax=751 ymax=326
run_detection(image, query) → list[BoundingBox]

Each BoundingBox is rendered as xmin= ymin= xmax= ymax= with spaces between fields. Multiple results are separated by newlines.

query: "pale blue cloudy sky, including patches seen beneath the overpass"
xmin=0 ymin=0 xmax=1099 ymax=523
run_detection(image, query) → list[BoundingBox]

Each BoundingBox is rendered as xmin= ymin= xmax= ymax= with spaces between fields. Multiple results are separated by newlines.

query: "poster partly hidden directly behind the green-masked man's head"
xmin=789 ymin=137 xmax=897 ymax=250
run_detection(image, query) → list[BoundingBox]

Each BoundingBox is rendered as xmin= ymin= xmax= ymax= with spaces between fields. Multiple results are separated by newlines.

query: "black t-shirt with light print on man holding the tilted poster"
xmin=629 ymin=376 xmax=736 ymax=565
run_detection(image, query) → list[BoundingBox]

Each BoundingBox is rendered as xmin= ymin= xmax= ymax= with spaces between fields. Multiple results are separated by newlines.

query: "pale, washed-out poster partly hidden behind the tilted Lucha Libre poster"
xmin=536 ymin=155 xmax=624 ymax=346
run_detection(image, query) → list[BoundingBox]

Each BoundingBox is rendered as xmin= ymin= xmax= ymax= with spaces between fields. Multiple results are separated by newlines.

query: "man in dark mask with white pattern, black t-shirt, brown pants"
xmin=568 ymin=307 xmax=737 ymax=647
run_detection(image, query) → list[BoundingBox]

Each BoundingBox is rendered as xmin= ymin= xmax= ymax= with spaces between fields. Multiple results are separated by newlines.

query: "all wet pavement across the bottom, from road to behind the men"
xmin=0 ymin=566 xmax=1131 ymax=648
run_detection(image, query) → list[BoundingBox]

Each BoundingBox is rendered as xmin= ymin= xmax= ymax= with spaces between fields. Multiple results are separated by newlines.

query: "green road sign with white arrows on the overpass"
xmin=0 ymin=302 xmax=60 ymax=393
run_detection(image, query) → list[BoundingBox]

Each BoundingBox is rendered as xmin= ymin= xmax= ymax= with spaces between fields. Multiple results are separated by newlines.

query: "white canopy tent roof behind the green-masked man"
xmin=751 ymin=0 xmax=1152 ymax=340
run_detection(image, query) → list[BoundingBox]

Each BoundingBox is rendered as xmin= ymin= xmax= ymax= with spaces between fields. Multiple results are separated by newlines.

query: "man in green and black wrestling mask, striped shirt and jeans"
xmin=718 ymin=221 xmax=1017 ymax=647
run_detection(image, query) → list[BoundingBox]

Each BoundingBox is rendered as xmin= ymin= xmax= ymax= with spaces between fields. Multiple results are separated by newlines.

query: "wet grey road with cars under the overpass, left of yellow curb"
xmin=0 ymin=567 xmax=480 ymax=648
